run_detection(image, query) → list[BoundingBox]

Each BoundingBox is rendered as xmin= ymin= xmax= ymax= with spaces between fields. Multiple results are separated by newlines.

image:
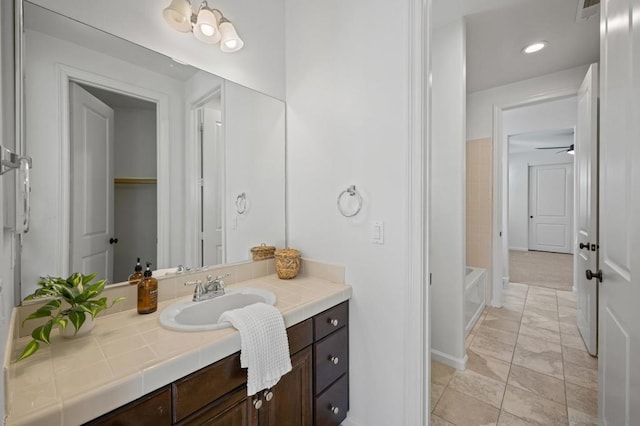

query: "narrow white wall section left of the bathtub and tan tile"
xmin=430 ymin=20 xmax=466 ymax=368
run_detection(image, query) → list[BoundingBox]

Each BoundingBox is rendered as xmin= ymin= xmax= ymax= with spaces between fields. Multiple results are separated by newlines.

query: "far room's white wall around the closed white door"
xmin=508 ymin=150 xmax=573 ymax=250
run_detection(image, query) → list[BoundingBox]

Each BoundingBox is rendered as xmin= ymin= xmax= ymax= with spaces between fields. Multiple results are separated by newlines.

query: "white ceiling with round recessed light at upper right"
xmin=433 ymin=0 xmax=600 ymax=92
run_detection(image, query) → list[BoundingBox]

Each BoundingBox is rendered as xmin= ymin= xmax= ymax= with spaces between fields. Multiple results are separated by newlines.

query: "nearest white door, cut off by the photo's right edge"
xmin=592 ymin=0 xmax=640 ymax=426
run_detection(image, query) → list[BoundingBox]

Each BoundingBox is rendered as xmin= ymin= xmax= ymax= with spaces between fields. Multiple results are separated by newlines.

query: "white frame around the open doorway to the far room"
xmin=491 ymin=86 xmax=579 ymax=307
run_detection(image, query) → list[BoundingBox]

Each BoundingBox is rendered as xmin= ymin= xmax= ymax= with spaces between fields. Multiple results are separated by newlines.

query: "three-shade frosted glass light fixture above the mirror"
xmin=162 ymin=0 xmax=244 ymax=53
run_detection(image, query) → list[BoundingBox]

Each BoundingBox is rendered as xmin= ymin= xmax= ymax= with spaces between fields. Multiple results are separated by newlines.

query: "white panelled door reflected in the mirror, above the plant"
xmin=69 ymin=83 xmax=114 ymax=281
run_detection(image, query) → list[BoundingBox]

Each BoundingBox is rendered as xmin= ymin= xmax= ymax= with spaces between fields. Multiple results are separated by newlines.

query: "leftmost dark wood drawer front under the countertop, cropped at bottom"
xmin=85 ymin=386 xmax=171 ymax=426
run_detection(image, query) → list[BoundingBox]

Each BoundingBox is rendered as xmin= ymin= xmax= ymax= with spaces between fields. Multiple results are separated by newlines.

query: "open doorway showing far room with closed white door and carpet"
xmin=502 ymin=96 xmax=577 ymax=291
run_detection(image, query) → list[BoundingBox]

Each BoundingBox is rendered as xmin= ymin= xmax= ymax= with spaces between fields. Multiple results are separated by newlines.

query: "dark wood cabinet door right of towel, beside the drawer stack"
xmin=260 ymin=347 xmax=313 ymax=426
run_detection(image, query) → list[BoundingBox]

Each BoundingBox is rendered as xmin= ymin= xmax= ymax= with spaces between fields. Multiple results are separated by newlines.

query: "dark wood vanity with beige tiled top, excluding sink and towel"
xmin=5 ymin=272 xmax=351 ymax=426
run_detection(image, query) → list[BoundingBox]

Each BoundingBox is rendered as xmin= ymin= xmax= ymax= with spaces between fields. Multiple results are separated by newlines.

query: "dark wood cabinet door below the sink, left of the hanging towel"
xmin=179 ymin=387 xmax=258 ymax=426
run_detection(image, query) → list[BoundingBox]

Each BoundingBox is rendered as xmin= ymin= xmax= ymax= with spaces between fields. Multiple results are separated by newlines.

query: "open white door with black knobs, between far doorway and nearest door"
xmin=573 ymin=64 xmax=598 ymax=355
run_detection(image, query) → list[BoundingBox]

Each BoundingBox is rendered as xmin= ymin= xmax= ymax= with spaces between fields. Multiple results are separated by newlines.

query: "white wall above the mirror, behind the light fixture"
xmin=34 ymin=0 xmax=284 ymax=99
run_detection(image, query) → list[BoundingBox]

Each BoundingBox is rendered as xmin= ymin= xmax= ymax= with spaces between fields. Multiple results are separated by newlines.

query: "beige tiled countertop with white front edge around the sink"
xmin=5 ymin=275 xmax=351 ymax=426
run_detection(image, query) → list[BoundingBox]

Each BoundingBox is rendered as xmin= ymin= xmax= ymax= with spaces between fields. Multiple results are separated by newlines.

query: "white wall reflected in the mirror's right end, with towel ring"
xmin=222 ymin=81 xmax=286 ymax=262
